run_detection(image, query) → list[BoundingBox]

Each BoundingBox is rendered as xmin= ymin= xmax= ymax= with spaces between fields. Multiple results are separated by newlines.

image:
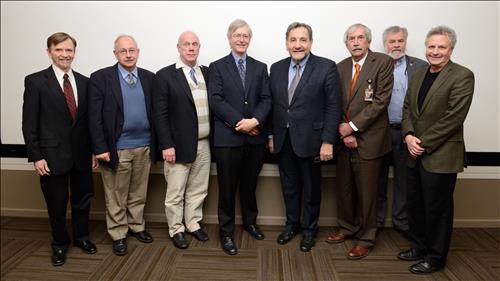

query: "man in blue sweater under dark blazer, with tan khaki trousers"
xmin=89 ymin=35 xmax=155 ymax=256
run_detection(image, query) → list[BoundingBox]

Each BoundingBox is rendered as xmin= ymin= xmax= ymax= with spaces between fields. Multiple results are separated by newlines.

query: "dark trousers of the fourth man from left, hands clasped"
xmin=214 ymin=144 xmax=266 ymax=236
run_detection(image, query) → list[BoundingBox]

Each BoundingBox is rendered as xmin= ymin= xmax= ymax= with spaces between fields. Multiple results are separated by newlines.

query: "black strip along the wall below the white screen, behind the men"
xmin=1 ymin=144 xmax=500 ymax=167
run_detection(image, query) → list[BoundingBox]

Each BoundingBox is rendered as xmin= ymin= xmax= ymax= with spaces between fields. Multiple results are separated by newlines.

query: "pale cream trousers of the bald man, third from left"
xmin=164 ymin=139 xmax=210 ymax=237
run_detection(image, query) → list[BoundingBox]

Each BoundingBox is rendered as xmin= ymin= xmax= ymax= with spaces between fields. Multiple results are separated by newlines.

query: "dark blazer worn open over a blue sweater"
xmin=89 ymin=64 xmax=156 ymax=169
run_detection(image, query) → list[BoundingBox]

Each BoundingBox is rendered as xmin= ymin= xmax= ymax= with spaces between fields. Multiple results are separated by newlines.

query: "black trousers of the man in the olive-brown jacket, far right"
xmin=408 ymin=160 xmax=457 ymax=266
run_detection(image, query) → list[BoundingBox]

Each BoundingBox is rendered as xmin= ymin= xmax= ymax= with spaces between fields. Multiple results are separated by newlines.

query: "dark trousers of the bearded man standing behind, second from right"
xmin=377 ymin=128 xmax=408 ymax=231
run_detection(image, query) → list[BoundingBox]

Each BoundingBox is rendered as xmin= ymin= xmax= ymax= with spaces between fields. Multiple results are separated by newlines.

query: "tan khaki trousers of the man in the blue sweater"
xmin=101 ymin=147 xmax=151 ymax=240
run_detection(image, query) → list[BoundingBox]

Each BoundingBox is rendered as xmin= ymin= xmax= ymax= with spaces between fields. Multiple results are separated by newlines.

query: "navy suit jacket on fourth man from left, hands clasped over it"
xmin=208 ymin=54 xmax=271 ymax=147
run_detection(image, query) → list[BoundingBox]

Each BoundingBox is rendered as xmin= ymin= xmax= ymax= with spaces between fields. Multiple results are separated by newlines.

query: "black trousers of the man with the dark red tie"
xmin=40 ymin=164 xmax=94 ymax=247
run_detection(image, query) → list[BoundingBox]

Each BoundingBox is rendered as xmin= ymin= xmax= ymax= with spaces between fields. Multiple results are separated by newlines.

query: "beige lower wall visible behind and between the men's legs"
xmin=1 ymin=162 xmax=500 ymax=227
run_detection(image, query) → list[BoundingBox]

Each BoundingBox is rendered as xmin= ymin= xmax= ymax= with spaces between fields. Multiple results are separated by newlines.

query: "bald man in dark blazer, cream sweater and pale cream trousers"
xmin=153 ymin=31 xmax=210 ymax=249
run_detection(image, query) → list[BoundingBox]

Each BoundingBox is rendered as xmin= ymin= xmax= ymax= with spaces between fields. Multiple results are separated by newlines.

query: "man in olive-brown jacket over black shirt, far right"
xmin=398 ymin=26 xmax=474 ymax=274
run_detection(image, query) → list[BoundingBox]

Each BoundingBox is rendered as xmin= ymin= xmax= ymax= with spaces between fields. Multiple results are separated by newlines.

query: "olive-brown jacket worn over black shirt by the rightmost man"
xmin=402 ymin=61 xmax=474 ymax=173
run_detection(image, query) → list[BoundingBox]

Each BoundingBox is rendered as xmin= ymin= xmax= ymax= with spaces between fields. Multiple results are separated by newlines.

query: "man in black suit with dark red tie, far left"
xmin=22 ymin=32 xmax=99 ymax=266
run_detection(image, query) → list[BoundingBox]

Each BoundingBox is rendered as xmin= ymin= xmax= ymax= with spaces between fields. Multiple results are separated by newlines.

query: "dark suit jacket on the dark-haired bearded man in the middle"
xmin=271 ymin=54 xmax=341 ymax=157
